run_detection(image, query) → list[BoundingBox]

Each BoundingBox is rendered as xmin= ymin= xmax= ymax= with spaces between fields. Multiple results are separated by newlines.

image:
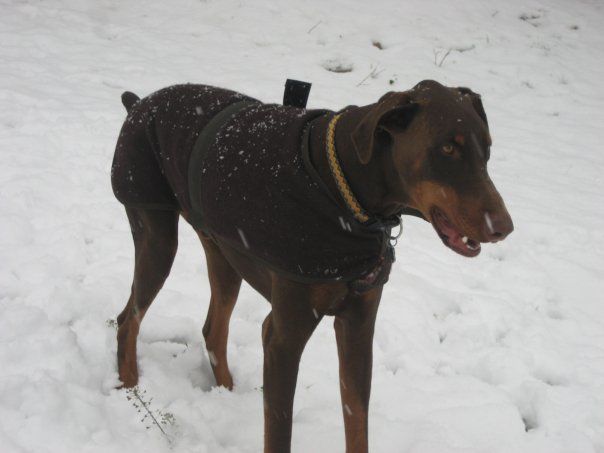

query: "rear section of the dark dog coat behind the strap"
xmin=111 ymin=84 xmax=259 ymax=210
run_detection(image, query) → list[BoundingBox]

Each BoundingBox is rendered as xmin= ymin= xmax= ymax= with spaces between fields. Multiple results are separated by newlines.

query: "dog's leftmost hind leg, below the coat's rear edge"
xmin=117 ymin=207 xmax=179 ymax=387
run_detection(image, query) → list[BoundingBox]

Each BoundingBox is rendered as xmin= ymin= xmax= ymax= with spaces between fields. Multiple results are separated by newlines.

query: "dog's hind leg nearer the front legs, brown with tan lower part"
xmin=199 ymin=233 xmax=241 ymax=390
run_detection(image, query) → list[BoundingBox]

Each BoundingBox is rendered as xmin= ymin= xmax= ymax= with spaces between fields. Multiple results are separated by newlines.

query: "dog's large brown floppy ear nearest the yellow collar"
xmin=351 ymin=91 xmax=418 ymax=164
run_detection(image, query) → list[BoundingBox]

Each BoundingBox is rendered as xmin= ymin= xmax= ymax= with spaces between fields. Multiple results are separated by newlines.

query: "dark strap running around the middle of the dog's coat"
xmin=188 ymin=101 xmax=259 ymax=232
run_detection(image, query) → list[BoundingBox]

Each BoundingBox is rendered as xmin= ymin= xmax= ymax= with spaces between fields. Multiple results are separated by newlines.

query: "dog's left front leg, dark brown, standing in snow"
xmin=262 ymin=281 xmax=320 ymax=453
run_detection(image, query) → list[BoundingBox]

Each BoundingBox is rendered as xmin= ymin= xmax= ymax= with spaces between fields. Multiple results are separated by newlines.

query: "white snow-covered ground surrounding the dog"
xmin=0 ymin=0 xmax=604 ymax=453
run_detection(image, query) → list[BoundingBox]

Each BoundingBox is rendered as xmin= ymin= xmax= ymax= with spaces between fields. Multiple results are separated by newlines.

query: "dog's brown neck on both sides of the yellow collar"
xmin=310 ymin=107 xmax=407 ymax=217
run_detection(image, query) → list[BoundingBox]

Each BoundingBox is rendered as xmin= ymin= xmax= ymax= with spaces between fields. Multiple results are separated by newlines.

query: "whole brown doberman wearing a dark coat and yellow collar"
xmin=112 ymin=81 xmax=513 ymax=452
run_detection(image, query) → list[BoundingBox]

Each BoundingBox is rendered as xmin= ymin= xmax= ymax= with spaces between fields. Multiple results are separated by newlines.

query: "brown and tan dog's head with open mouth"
xmin=352 ymin=80 xmax=514 ymax=257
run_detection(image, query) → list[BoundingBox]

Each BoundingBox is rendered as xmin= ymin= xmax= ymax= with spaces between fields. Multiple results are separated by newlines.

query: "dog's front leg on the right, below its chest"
xmin=334 ymin=287 xmax=382 ymax=453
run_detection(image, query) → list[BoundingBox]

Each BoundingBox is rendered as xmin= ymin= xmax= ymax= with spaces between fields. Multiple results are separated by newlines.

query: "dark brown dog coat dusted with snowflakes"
xmin=112 ymin=85 xmax=393 ymax=283
